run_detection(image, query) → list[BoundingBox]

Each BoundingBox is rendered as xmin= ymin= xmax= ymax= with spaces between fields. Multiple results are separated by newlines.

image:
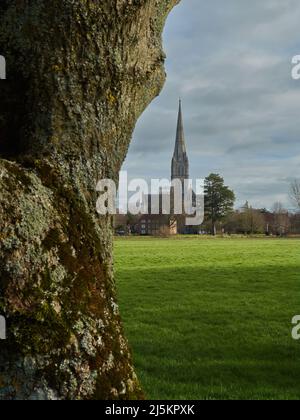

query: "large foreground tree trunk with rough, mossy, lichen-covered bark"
xmin=0 ymin=0 xmax=178 ymax=399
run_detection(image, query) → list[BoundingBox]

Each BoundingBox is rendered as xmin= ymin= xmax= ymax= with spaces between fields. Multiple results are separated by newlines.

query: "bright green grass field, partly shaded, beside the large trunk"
xmin=115 ymin=237 xmax=300 ymax=400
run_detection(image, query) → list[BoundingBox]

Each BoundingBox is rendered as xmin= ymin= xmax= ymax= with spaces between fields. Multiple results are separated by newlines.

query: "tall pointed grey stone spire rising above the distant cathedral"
xmin=172 ymin=99 xmax=189 ymax=180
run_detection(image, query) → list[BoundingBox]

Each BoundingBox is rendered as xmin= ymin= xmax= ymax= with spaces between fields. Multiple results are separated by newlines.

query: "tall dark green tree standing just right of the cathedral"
xmin=204 ymin=174 xmax=235 ymax=235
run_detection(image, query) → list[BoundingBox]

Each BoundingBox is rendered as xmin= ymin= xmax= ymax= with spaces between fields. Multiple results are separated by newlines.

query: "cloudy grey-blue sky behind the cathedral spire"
xmin=123 ymin=0 xmax=300 ymax=208
